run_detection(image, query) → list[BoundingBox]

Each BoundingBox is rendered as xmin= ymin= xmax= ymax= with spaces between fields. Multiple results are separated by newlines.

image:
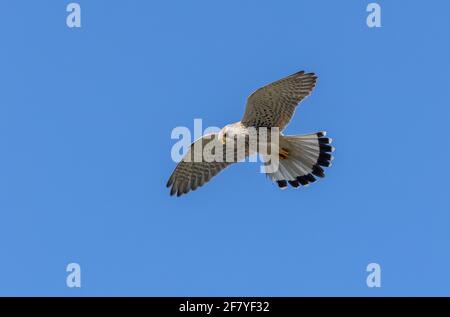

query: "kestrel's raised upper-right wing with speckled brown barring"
xmin=241 ymin=71 xmax=317 ymax=130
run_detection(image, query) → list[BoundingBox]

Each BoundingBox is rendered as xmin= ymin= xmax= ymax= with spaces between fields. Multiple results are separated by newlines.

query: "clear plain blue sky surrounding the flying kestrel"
xmin=0 ymin=0 xmax=450 ymax=296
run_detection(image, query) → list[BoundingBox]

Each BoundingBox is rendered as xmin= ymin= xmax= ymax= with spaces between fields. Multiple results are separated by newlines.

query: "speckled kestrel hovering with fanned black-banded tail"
xmin=167 ymin=71 xmax=334 ymax=196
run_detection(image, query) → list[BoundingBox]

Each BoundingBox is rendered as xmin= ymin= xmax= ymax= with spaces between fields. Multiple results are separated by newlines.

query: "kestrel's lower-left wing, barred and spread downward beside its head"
xmin=167 ymin=134 xmax=232 ymax=196
